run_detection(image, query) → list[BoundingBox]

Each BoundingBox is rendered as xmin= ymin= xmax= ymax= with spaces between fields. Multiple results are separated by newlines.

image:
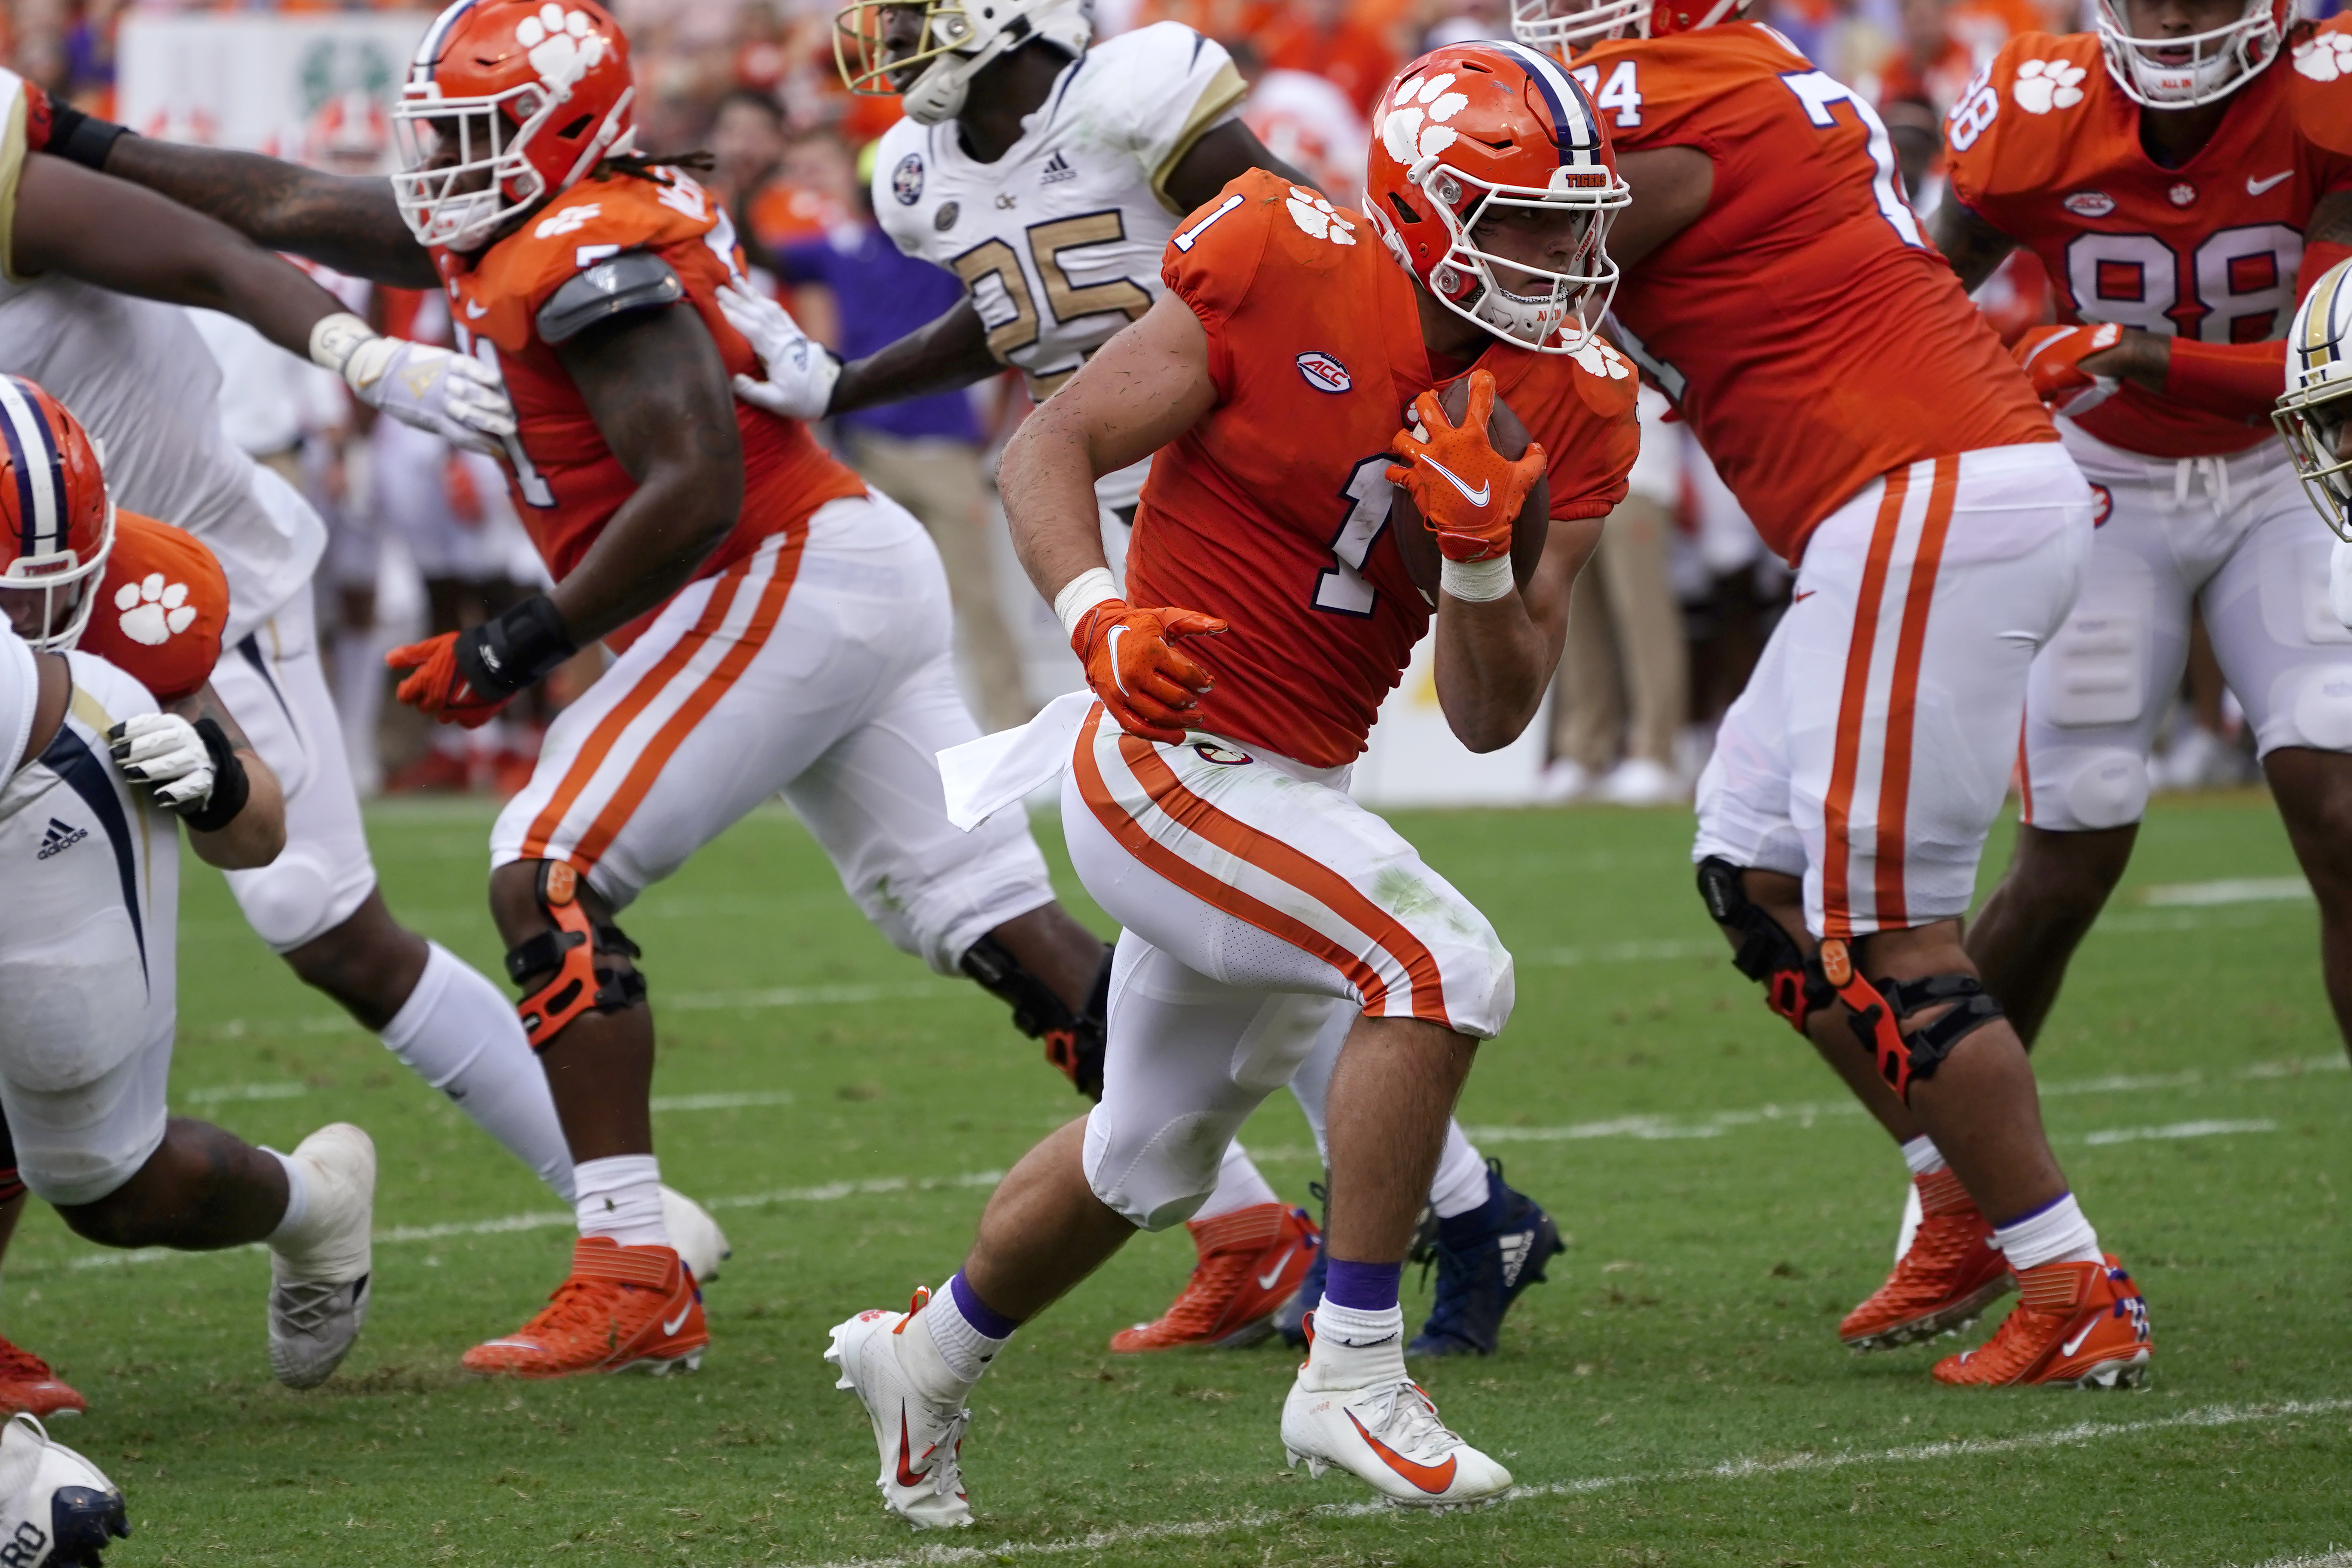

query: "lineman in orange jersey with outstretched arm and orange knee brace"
xmin=80 ymin=0 xmax=1119 ymax=1378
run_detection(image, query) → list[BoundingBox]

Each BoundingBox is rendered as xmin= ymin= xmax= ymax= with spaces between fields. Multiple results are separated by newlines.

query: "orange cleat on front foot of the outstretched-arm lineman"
xmin=466 ymin=1237 xmax=710 ymax=1378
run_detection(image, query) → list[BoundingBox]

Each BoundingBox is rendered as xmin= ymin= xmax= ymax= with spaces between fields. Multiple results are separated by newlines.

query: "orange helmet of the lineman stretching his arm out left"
xmin=393 ymin=0 xmax=637 ymax=251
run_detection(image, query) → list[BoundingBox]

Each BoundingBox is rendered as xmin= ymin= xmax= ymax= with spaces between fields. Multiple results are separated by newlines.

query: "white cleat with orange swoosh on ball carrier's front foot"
xmin=1282 ymin=1361 xmax=1510 ymax=1509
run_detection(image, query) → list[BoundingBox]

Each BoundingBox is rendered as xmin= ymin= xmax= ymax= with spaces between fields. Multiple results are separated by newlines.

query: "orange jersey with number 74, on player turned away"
xmin=1571 ymin=21 xmax=2058 ymax=564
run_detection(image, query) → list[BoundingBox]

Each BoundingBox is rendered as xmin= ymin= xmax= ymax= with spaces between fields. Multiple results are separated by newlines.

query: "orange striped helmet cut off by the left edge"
xmin=0 ymin=376 xmax=115 ymax=651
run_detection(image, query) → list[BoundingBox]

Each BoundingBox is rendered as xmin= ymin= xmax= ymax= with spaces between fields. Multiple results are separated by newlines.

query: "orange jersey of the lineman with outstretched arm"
xmin=433 ymin=169 xmax=865 ymax=620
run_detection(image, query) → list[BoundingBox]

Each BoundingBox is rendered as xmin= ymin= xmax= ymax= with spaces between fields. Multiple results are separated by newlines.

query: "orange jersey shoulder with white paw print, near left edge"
xmin=75 ymin=510 xmax=228 ymax=703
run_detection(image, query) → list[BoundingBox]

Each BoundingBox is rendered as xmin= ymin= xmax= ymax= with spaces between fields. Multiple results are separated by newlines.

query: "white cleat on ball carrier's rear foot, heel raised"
xmin=825 ymin=1290 xmax=971 ymax=1530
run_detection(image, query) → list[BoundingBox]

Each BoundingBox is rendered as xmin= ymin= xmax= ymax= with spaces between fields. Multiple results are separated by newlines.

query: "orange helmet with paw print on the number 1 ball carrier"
xmin=1364 ymin=42 xmax=1632 ymax=355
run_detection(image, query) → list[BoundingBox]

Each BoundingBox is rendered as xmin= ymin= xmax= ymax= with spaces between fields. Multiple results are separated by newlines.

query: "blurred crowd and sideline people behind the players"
xmin=0 ymin=0 xmax=2345 ymax=804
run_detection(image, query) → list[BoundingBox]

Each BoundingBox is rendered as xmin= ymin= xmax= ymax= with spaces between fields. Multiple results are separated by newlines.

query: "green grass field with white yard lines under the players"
xmin=0 ymin=797 xmax=2352 ymax=1568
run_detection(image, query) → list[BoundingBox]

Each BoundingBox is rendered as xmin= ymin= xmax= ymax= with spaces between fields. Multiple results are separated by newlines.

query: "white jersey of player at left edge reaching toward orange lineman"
xmin=0 ymin=70 xmax=327 ymax=644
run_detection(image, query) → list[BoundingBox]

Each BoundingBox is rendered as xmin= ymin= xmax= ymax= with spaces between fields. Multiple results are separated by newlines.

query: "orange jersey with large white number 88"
xmin=1945 ymin=16 xmax=2352 ymax=458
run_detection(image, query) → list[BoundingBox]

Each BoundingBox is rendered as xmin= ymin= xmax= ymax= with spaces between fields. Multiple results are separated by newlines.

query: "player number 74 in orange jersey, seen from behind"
xmin=1515 ymin=0 xmax=2150 ymax=1385
